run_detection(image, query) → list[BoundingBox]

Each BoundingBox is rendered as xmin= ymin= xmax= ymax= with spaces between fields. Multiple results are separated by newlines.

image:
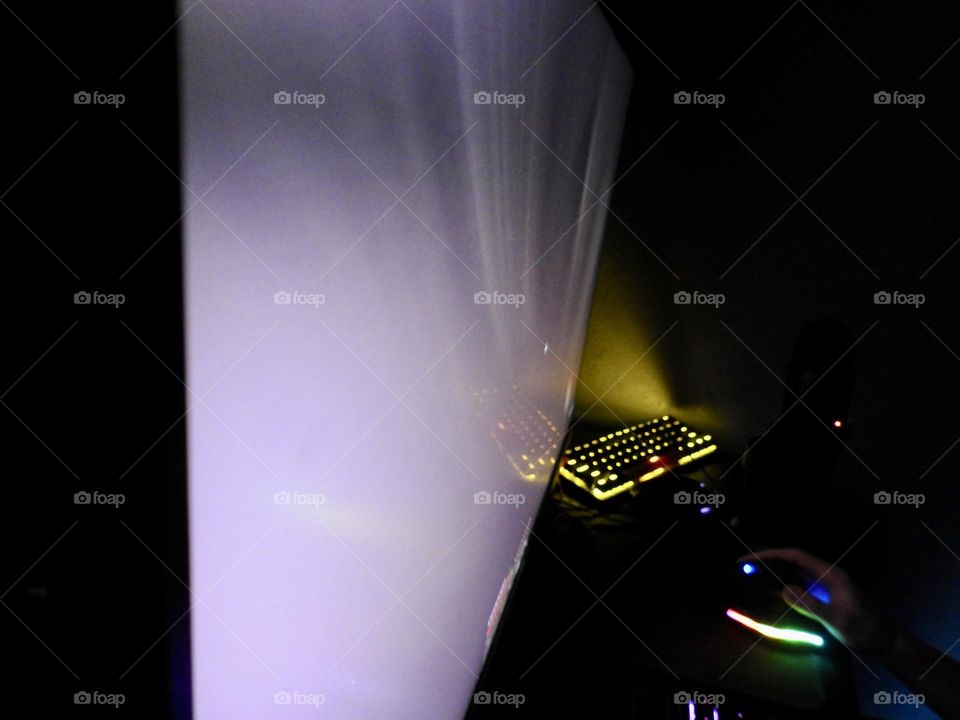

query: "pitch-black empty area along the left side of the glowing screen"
xmin=0 ymin=2 xmax=189 ymax=717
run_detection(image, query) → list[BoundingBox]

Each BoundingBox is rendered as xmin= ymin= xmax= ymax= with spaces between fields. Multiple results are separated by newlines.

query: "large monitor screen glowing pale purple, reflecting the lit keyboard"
xmin=179 ymin=0 xmax=630 ymax=720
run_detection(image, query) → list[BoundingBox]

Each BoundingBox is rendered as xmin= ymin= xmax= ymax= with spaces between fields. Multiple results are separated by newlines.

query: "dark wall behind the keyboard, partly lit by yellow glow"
xmin=574 ymin=2 xmax=960 ymax=716
